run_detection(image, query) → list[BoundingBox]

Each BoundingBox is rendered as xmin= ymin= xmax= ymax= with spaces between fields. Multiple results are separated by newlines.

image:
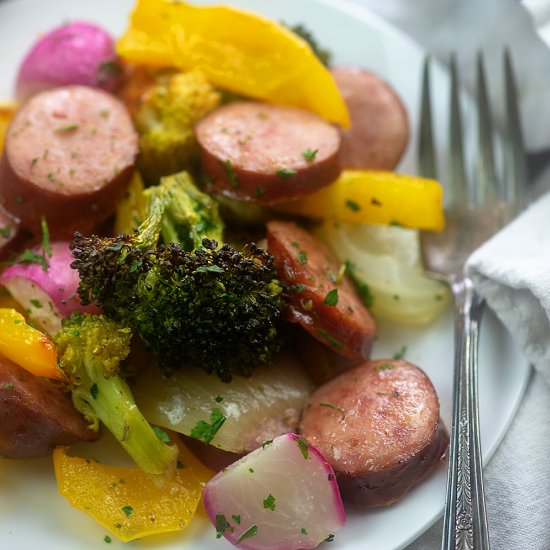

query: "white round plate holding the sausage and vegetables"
xmin=0 ymin=0 xmax=530 ymax=550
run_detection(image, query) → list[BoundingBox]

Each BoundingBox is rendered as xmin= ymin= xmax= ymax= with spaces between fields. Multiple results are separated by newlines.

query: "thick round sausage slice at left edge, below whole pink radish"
xmin=0 ymin=86 xmax=138 ymax=238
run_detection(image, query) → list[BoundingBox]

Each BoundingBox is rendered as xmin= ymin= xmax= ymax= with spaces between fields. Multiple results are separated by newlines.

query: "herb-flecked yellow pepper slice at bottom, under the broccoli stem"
xmin=53 ymin=442 xmax=214 ymax=542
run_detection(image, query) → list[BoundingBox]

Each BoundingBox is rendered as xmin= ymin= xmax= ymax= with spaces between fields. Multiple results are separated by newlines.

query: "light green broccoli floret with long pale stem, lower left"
xmin=54 ymin=313 xmax=178 ymax=475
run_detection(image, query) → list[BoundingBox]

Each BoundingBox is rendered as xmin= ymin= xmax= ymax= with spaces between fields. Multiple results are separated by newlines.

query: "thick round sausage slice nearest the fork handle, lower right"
xmin=300 ymin=360 xmax=449 ymax=507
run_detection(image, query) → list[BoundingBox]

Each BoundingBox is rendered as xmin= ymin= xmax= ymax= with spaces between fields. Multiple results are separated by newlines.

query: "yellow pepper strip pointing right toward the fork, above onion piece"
xmin=274 ymin=170 xmax=445 ymax=231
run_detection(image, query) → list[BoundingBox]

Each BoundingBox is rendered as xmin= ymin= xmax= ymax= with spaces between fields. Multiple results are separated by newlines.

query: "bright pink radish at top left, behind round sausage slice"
xmin=16 ymin=22 xmax=121 ymax=100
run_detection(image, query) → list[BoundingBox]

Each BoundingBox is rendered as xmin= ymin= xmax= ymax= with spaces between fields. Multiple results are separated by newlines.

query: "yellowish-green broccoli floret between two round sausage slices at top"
xmin=134 ymin=71 xmax=220 ymax=185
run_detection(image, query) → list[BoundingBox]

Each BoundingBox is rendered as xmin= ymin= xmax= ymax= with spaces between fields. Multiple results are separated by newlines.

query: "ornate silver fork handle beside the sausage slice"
xmin=442 ymin=277 xmax=489 ymax=550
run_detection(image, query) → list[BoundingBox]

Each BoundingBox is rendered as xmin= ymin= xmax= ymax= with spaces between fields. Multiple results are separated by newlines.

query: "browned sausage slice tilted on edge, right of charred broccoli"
xmin=267 ymin=220 xmax=376 ymax=359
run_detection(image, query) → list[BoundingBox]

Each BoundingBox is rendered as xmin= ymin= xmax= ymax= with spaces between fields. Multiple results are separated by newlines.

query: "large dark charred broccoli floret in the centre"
xmin=71 ymin=181 xmax=284 ymax=381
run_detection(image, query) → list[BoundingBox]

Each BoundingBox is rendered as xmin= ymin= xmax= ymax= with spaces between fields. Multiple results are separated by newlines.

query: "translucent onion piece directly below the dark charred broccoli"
xmin=132 ymin=352 xmax=313 ymax=453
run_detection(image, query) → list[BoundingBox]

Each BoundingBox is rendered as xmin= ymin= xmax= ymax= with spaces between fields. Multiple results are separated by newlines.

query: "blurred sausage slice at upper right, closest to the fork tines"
xmin=331 ymin=67 xmax=409 ymax=170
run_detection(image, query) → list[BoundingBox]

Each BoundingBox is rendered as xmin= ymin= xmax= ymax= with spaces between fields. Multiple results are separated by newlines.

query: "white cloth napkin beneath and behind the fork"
xmin=355 ymin=0 xmax=550 ymax=550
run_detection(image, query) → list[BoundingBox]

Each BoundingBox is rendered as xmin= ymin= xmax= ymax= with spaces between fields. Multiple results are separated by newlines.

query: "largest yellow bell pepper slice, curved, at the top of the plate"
xmin=116 ymin=0 xmax=349 ymax=127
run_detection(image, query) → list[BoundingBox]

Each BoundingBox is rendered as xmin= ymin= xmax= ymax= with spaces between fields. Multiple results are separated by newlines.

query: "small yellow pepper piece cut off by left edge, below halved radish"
xmin=0 ymin=308 xmax=67 ymax=381
